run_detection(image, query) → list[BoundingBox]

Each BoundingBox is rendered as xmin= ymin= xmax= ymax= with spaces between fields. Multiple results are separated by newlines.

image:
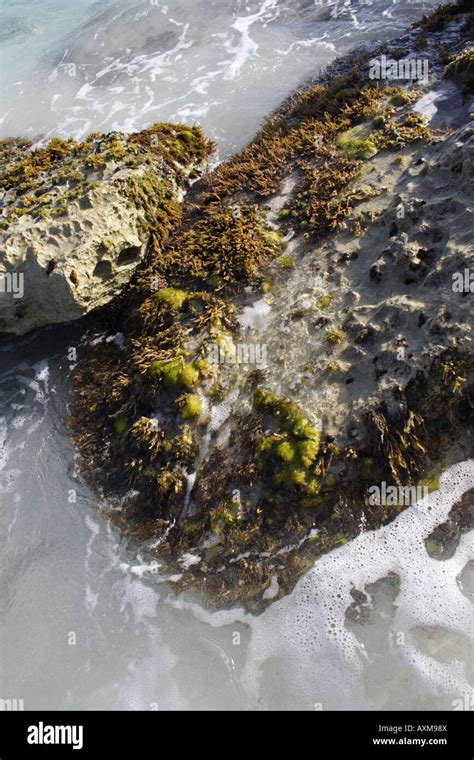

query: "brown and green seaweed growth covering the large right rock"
xmin=66 ymin=0 xmax=474 ymax=608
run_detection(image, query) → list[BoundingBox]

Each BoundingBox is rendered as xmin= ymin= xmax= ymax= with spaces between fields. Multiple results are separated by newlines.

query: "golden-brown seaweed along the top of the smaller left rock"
xmin=0 ymin=123 xmax=214 ymax=235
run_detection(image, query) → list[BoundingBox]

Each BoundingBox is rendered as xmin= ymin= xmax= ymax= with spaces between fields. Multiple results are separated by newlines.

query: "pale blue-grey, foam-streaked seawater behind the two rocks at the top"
xmin=0 ymin=0 xmax=440 ymax=157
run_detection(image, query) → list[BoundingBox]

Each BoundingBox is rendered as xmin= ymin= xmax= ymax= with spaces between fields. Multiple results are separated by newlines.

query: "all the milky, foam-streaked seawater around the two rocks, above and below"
xmin=0 ymin=0 xmax=473 ymax=710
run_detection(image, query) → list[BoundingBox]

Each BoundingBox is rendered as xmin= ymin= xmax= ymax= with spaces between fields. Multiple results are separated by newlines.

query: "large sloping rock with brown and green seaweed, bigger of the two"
xmin=58 ymin=2 xmax=474 ymax=610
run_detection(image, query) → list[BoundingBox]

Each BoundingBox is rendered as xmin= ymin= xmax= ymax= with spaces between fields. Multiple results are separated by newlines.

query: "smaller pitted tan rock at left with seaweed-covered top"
xmin=0 ymin=124 xmax=212 ymax=334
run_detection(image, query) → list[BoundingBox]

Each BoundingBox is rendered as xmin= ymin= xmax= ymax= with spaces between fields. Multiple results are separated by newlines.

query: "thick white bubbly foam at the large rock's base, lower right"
xmin=171 ymin=462 xmax=474 ymax=709
